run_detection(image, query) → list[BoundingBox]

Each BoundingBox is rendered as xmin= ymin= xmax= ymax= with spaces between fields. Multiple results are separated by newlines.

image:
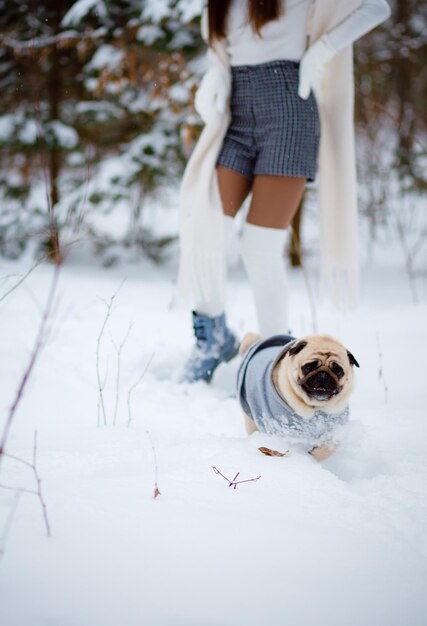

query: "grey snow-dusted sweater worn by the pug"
xmin=237 ymin=335 xmax=349 ymax=446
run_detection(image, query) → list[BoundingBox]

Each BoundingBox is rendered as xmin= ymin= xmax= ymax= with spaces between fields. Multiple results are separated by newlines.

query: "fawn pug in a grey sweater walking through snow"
xmin=237 ymin=333 xmax=359 ymax=461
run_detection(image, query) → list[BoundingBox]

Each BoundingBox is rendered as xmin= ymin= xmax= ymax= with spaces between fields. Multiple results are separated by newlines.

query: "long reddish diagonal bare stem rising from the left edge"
xmin=0 ymin=265 xmax=60 ymax=465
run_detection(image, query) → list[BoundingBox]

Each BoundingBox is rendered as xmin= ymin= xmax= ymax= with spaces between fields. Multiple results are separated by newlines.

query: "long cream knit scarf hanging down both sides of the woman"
xmin=178 ymin=0 xmax=361 ymax=309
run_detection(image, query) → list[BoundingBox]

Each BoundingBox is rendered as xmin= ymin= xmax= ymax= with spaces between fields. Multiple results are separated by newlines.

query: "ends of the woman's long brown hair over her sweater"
xmin=208 ymin=0 xmax=282 ymax=42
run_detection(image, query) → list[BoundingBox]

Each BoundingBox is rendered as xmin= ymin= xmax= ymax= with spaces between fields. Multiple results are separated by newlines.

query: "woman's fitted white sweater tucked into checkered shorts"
xmin=227 ymin=0 xmax=390 ymax=65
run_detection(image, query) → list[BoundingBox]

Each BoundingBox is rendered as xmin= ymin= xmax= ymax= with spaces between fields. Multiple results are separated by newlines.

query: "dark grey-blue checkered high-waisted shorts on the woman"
xmin=217 ymin=61 xmax=320 ymax=181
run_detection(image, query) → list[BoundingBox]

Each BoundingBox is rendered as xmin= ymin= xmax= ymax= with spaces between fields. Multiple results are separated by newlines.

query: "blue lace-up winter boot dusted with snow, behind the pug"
xmin=180 ymin=311 xmax=239 ymax=383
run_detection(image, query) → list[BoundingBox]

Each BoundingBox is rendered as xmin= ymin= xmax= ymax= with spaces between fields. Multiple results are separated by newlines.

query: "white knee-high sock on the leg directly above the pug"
xmin=240 ymin=222 xmax=289 ymax=337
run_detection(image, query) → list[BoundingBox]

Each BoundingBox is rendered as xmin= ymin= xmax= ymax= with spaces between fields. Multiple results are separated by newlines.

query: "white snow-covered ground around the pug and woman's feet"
xmin=0 ymin=235 xmax=427 ymax=626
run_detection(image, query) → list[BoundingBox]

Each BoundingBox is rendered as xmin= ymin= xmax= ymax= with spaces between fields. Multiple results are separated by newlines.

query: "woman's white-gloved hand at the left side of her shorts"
xmin=194 ymin=65 xmax=231 ymax=124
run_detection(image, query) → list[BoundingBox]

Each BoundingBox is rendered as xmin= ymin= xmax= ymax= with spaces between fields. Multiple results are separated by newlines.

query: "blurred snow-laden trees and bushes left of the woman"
xmin=0 ymin=0 xmax=206 ymax=256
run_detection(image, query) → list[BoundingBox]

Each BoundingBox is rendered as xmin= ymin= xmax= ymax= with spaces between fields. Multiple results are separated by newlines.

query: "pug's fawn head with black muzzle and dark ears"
xmin=280 ymin=335 xmax=359 ymax=411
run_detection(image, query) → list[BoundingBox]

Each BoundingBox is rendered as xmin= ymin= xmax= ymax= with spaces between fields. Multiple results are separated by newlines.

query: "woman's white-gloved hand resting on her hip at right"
xmin=298 ymin=38 xmax=335 ymax=101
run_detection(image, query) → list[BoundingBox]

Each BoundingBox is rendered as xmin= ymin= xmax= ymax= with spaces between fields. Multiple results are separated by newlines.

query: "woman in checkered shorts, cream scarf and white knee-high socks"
xmin=179 ymin=0 xmax=390 ymax=382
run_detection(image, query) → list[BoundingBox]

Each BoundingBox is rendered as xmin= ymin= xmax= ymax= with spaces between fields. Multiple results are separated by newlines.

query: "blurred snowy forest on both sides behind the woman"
xmin=0 ymin=0 xmax=427 ymax=290
